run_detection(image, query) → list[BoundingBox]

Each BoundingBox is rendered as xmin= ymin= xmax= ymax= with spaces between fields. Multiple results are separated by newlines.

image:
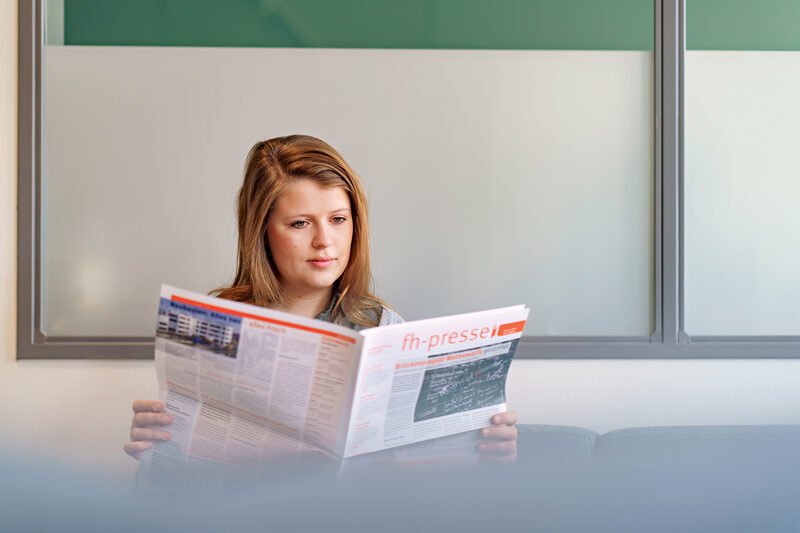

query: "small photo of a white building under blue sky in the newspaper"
xmin=156 ymin=298 xmax=242 ymax=359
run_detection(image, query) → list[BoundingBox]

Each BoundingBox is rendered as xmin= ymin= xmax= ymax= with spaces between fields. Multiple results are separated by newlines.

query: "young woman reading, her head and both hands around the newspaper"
xmin=124 ymin=135 xmax=517 ymax=458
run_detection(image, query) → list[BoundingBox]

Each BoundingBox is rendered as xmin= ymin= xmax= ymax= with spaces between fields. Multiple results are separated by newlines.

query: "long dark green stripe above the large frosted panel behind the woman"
xmin=64 ymin=0 xmax=654 ymax=50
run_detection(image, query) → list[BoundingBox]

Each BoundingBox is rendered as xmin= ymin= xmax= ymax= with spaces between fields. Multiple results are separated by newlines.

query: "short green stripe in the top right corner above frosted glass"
xmin=686 ymin=0 xmax=800 ymax=50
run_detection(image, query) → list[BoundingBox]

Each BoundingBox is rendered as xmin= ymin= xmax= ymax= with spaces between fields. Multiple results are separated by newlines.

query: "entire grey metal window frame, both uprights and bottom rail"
xmin=17 ymin=0 xmax=800 ymax=359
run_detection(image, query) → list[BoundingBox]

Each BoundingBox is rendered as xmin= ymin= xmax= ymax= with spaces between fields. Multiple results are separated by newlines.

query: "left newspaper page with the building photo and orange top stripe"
xmin=140 ymin=285 xmax=362 ymax=486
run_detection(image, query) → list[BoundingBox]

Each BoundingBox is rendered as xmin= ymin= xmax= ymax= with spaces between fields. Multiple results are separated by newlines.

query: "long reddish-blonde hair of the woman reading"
xmin=212 ymin=135 xmax=383 ymax=326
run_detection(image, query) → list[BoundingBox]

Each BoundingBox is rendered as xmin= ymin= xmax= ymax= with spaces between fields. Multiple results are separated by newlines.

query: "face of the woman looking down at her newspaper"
xmin=267 ymin=179 xmax=353 ymax=297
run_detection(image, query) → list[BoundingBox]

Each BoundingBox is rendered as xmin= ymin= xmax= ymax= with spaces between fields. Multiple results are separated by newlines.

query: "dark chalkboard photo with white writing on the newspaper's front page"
xmin=414 ymin=339 xmax=519 ymax=422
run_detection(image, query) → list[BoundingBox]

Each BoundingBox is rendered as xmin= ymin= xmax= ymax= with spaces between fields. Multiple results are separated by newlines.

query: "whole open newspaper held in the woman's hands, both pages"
xmin=142 ymin=286 xmax=528 ymax=469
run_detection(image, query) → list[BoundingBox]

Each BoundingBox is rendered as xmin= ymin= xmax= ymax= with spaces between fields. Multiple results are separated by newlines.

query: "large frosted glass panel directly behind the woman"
xmin=43 ymin=46 xmax=654 ymax=335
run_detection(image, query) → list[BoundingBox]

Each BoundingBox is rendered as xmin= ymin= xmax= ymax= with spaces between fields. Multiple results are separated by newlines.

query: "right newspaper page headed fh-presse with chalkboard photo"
xmin=342 ymin=305 xmax=528 ymax=457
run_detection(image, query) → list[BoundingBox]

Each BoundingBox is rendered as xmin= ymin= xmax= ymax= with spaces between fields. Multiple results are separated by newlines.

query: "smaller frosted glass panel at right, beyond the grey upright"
xmin=684 ymin=51 xmax=800 ymax=335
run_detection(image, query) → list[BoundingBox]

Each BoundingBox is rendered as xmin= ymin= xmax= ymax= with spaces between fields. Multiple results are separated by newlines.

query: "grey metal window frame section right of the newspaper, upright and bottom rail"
xmin=515 ymin=0 xmax=800 ymax=359
